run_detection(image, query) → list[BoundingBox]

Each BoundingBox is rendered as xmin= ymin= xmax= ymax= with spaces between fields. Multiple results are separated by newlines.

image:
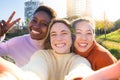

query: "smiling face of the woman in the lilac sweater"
xmin=28 ymin=11 xmax=51 ymax=40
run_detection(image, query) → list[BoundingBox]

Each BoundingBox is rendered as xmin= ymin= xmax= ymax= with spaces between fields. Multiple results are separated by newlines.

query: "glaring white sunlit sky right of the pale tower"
xmin=91 ymin=0 xmax=120 ymax=21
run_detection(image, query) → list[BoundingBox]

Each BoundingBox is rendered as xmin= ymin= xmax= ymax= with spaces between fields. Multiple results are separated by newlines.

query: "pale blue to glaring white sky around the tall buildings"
xmin=0 ymin=0 xmax=120 ymax=21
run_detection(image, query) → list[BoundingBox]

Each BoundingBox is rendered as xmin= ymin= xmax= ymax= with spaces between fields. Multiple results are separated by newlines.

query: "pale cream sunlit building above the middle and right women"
xmin=67 ymin=0 xmax=91 ymax=17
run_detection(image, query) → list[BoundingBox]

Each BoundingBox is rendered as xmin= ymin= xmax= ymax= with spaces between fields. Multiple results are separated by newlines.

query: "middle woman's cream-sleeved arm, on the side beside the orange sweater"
xmin=65 ymin=56 xmax=94 ymax=80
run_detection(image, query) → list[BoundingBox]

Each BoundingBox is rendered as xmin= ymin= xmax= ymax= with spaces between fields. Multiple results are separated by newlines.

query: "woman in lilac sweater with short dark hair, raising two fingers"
xmin=0 ymin=5 xmax=56 ymax=67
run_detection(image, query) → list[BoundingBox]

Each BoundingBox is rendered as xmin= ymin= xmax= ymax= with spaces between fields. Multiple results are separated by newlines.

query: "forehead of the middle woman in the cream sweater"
xmin=51 ymin=22 xmax=70 ymax=32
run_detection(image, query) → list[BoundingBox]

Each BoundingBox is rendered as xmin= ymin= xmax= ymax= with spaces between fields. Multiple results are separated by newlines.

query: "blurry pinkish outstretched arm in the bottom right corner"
xmin=74 ymin=61 xmax=120 ymax=80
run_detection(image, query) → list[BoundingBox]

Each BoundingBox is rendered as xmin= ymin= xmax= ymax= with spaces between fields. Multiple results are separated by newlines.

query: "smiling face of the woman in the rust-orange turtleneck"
xmin=74 ymin=21 xmax=95 ymax=52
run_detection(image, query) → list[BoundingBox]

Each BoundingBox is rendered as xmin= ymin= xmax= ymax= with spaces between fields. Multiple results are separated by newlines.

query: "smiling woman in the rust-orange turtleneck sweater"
xmin=72 ymin=18 xmax=117 ymax=70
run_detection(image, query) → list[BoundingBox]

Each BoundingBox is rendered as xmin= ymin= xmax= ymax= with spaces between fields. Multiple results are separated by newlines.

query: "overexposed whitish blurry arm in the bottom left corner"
xmin=0 ymin=58 xmax=40 ymax=80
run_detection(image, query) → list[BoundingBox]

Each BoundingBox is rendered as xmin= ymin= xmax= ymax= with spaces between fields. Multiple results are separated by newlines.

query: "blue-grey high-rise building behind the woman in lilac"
xmin=24 ymin=0 xmax=43 ymax=20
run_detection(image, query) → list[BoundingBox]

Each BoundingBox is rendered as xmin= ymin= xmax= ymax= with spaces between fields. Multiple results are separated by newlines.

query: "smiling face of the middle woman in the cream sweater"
xmin=50 ymin=22 xmax=72 ymax=53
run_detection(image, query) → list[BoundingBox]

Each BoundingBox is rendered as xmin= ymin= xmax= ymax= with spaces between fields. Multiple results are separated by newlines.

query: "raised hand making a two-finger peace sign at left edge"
xmin=0 ymin=11 xmax=20 ymax=36
